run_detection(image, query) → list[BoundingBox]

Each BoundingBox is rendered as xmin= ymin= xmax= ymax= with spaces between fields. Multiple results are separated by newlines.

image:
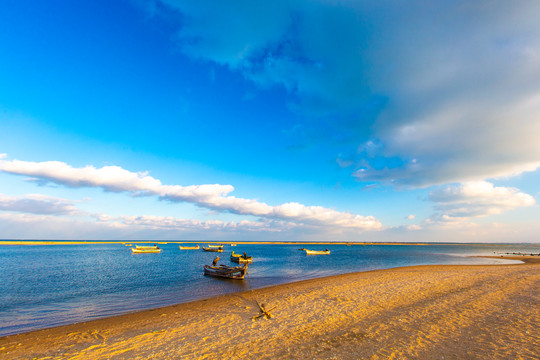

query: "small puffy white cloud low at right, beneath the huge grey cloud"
xmin=429 ymin=181 xmax=535 ymax=222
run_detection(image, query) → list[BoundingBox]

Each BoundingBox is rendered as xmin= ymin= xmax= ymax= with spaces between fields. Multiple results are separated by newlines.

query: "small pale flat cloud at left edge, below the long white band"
xmin=0 ymin=194 xmax=80 ymax=215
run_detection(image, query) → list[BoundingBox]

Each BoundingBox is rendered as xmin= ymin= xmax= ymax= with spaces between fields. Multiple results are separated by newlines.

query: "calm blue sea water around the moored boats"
xmin=0 ymin=244 xmax=539 ymax=336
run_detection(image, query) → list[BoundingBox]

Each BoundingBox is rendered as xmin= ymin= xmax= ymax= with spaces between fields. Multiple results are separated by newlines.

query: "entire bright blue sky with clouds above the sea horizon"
xmin=0 ymin=0 xmax=540 ymax=243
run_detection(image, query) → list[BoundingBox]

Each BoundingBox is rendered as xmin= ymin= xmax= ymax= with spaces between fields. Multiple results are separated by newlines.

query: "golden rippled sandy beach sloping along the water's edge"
xmin=0 ymin=257 xmax=540 ymax=359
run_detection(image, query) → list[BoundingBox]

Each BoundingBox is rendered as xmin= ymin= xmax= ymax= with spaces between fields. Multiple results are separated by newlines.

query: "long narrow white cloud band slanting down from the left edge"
xmin=0 ymin=160 xmax=382 ymax=230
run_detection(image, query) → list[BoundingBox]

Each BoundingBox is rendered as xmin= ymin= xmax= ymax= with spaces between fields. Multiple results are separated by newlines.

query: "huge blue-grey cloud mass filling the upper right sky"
xmin=151 ymin=0 xmax=540 ymax=187
